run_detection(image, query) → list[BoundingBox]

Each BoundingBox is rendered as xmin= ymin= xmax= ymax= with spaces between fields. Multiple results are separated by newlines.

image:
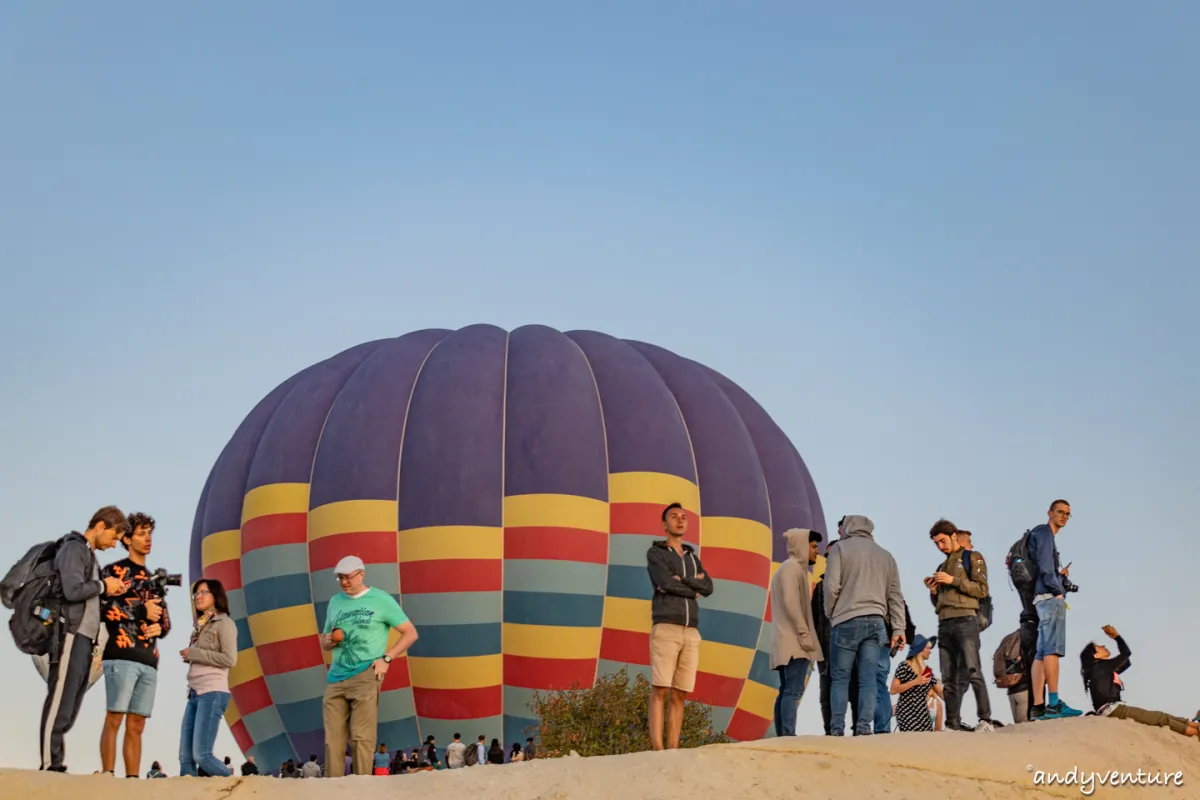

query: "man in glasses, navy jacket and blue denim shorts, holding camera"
xmin=1028 ymin=500 xmax=1081 ymax=721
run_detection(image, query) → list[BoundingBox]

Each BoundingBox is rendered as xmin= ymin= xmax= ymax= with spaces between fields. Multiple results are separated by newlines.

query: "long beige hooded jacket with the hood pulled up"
xmin=770 ymin=528 xmax=824 ymax=669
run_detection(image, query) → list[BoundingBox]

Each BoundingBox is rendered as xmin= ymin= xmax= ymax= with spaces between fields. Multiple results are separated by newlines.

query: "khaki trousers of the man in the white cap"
xmin=322 ymin=667 xmax=379 ymax=777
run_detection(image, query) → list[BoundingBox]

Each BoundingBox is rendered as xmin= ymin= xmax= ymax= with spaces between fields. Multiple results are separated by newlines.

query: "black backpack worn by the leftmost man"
xmin=0 ymin=539 xmax=65 ymax=656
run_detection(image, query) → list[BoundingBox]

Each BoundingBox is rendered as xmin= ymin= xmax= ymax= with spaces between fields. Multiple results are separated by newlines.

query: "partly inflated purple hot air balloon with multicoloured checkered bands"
xmin=191 ymin=325 xmax=826 ymax=765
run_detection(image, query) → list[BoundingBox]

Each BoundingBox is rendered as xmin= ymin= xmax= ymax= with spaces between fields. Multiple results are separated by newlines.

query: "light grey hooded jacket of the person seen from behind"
xmin=823 ymin=516 xmax=905 ymax=631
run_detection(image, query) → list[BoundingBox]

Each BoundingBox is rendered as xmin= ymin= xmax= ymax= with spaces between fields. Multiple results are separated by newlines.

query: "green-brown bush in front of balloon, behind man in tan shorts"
xmin=529 ymin=668 xmax=730 ymax=757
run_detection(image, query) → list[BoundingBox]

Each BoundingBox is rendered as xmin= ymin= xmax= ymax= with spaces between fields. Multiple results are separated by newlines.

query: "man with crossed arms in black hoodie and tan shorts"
xmin=646 ymin=503 xmax=713 ymax=750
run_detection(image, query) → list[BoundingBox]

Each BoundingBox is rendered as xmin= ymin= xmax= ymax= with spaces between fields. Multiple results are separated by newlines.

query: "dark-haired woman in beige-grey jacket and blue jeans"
xmin=179 ymin=578 xmax=238 ymax=777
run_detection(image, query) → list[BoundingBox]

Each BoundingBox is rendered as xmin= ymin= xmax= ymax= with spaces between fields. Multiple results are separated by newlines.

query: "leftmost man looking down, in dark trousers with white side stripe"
xmin=41 ymin=506 xmax=130 ymax=772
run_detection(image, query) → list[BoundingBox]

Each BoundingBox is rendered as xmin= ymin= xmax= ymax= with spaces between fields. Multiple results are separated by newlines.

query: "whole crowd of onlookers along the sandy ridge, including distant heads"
xmin=5 ymin=500 xmax=1200 ymax=777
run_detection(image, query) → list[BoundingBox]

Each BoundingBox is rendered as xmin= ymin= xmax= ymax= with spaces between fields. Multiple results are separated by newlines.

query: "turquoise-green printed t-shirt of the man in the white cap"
xmin=324 ymin=587 xmax=408 ymax=684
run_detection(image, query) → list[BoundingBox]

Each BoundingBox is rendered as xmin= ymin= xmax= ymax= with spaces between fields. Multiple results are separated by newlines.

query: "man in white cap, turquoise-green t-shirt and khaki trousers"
xmin=320 ymin=555 xmax=416 ymax=777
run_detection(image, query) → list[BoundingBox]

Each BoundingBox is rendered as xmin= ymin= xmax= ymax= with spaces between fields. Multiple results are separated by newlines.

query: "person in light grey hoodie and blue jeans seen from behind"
xmin=824 ymin=516 xmax=905 ymax=736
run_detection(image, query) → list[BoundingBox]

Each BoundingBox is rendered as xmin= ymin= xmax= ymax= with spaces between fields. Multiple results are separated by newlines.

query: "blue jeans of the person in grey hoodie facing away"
xmin=829 ymin=614 xmax=888 ymax=736
